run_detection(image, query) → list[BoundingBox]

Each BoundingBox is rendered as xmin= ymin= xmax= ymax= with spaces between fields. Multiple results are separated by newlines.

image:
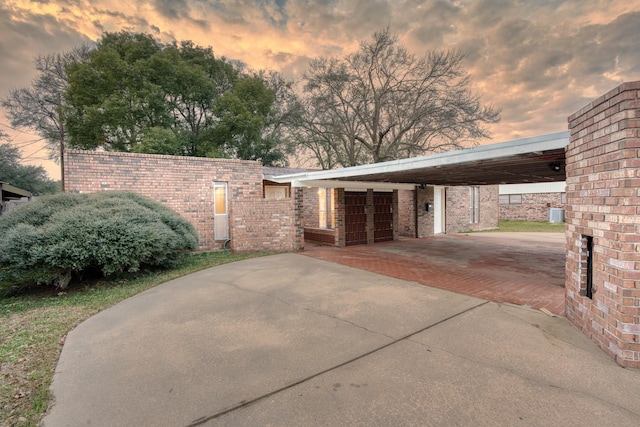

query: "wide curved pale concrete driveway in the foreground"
xmin=44 ymin=254 xmax=640 ymax=427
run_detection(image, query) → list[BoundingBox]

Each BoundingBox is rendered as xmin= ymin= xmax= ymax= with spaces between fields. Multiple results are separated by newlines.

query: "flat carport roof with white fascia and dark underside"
xmin=273 ymin=132 xmax=569 ymax=187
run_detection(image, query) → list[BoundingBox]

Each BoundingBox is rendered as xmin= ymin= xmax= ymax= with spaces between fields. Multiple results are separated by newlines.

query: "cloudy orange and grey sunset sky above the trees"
xmin=0 ymin=0 xmax=640 ymax=179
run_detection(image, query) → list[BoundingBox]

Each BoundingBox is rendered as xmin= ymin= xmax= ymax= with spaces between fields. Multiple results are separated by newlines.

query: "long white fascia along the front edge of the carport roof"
xmin=272 ymin=131 xmax=569 ymax=186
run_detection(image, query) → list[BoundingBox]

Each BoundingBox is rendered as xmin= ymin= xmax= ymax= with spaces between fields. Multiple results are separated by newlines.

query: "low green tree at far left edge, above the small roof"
xmin=0 ymin=143 xmax=60 ymax=196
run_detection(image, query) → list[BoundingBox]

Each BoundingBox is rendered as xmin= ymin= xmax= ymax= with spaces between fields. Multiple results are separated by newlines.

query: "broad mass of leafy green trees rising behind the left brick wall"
xmin=65 ymin=32 xmax=286 ymax=165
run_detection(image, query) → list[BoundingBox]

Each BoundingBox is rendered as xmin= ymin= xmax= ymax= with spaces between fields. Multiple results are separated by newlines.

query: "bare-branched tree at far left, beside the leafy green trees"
xmin=2 ymin=45 xmax=89 ymax=188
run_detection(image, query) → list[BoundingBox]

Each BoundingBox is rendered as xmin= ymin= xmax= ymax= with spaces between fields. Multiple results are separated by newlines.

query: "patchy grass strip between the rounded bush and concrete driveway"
xmin=0 ymin=252 xmax=267 ymax=426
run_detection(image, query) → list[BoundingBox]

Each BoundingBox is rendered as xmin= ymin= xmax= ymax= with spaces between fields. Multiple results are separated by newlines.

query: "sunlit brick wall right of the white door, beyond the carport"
xmin=445 ymin=185 xmax=499 ymax=234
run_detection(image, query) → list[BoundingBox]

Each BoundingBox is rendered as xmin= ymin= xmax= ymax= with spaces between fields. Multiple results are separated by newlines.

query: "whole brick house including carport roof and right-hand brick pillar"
xmin=65 ymin=81 xmax=640 ymax=368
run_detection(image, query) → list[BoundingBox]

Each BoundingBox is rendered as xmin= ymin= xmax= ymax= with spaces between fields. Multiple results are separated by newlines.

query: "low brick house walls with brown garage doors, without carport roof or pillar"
xmin=65 ymin=150 xmax=497 ymax=251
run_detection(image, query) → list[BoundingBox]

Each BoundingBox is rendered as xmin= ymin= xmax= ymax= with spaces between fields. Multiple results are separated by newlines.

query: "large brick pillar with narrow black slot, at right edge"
xmin=565 ymin=81 xmax=640 ymax=368
